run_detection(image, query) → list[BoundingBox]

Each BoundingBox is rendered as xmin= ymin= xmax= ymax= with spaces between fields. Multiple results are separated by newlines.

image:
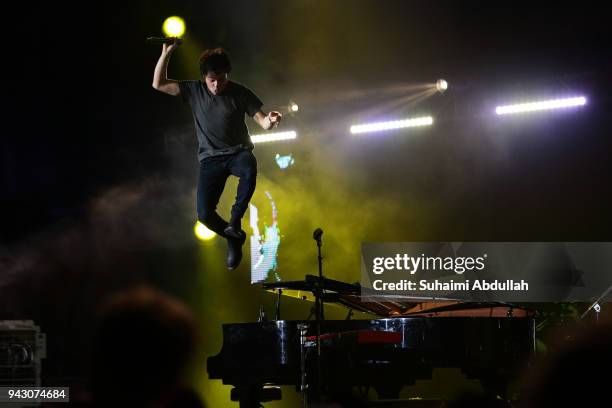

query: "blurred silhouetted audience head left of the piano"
xmin=92 ymin=287 xmax=202 ymax=407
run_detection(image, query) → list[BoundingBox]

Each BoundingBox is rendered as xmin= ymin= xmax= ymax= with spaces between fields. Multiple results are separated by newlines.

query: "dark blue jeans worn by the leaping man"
xmin=197 ymin=150 xmax=257 ymax=237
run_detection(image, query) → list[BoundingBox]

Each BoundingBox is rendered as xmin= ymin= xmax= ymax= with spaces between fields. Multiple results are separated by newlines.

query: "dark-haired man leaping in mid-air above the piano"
xmin=153 ymin=44 xmax=282 ymax=270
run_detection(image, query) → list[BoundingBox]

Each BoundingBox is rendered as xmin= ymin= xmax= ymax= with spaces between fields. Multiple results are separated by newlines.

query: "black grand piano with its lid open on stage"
xmin=207 ymin=275 xmax=535 ymax=408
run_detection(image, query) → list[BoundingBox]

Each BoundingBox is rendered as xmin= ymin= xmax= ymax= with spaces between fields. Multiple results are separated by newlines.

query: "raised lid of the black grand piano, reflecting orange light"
xmin=262 ymin=275 xmax=534 ymax=318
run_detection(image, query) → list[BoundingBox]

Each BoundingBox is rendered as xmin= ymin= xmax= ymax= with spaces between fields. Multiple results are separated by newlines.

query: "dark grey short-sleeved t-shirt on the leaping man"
xmin=179 ymin=81 xmax=263 ymax=161
